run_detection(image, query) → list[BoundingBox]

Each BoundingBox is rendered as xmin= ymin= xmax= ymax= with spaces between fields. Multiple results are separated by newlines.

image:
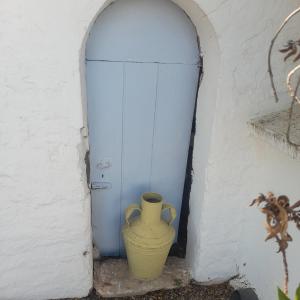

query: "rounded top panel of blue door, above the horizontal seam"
xmin=86 ymin=0 xmax=199 ymax=64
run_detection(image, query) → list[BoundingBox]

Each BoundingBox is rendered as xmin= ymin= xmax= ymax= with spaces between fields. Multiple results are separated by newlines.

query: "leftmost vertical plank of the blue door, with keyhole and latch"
xmin=87 ymin=61 xmax=124 ymax=255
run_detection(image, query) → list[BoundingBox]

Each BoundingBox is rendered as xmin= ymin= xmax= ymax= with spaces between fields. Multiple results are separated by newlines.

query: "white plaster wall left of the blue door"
xmin=0 ymin=0 xmax=92 ymax=300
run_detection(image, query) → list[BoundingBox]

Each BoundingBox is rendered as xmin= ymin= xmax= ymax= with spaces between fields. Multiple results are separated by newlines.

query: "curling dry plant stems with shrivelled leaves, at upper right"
xmin=268 ymin=7 xmax=300 ymax=148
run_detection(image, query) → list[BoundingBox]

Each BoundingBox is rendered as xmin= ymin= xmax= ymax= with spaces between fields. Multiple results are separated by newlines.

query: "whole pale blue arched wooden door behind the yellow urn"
xmin=86 ymin=0 xmax=200 ymax=255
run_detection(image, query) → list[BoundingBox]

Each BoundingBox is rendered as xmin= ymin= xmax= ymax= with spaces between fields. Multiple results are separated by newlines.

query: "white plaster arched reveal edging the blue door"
xmin=79 ymin=0 xmax=220 ymax=279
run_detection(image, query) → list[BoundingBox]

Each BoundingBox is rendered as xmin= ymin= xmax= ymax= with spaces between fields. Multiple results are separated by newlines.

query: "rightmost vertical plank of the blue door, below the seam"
xmin=150 ymin=64 xmax=199 ymax=239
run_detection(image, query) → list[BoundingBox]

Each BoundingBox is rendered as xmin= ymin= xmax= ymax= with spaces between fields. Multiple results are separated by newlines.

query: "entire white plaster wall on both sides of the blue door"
xmin=0 ymin=0 xmax=300 ymax=300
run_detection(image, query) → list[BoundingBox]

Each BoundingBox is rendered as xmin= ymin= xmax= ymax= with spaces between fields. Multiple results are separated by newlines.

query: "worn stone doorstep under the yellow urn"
xmin=94 ymin=257 xmax=190 ymax=298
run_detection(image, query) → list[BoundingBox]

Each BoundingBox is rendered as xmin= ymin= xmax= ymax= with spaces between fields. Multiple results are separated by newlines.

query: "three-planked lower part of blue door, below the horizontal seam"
xmin=87 ymin=61 xmax=199 ymax=256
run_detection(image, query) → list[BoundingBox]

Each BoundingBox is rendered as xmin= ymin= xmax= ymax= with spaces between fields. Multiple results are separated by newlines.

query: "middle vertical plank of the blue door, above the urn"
xmin=121 ymin=63 xmax=158 ymax=253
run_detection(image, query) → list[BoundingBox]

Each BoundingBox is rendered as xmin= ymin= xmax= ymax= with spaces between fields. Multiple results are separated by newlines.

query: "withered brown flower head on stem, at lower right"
xmin=250 ymin=192 xmax=300 ymax=295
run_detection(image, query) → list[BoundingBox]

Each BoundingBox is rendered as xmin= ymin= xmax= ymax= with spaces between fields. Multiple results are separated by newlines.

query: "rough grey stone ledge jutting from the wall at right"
xmin=248 ymin=105 xmax=300 ymax=160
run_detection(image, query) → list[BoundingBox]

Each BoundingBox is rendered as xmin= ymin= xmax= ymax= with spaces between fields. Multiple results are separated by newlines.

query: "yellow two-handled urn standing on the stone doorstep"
xmin=122 ymin=193 xmax=176 ymax=280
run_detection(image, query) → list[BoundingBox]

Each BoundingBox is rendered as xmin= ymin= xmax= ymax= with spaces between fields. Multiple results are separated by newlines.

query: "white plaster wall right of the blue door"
xmin=188 ymin=0 xmax=300 ymax=300
